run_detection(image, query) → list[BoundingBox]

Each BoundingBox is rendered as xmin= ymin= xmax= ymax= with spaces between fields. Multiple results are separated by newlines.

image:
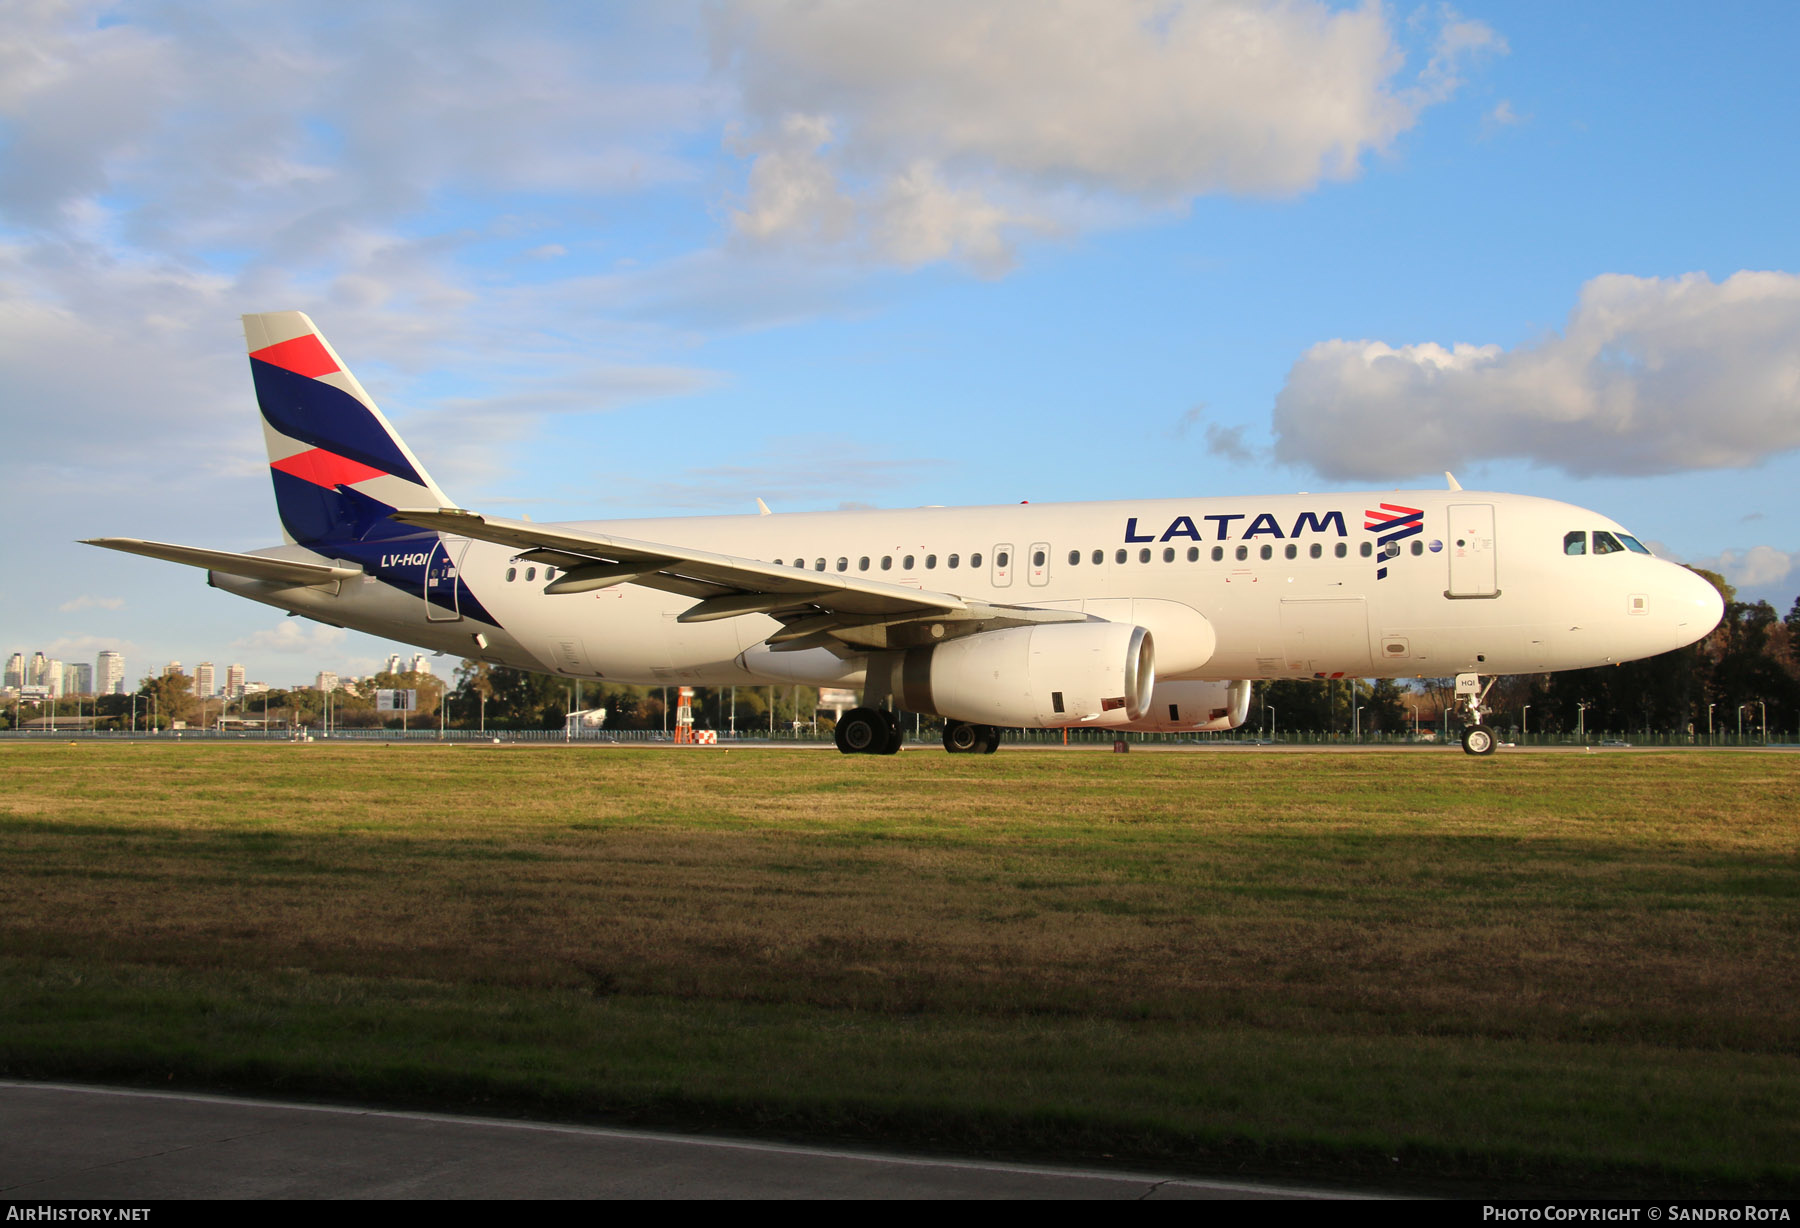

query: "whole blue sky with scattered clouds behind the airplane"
xmin=0 ymin=0 xmax=1800 ymax=684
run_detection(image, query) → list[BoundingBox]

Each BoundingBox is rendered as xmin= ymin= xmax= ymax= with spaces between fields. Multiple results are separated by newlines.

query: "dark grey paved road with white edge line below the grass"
xmin=0 ymin=1080 xmax=1360 ymax=1201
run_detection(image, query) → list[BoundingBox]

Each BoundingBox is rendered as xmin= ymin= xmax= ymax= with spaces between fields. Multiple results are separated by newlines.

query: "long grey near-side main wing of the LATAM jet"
xmin=391 ymin=508 xmax=1085 ymax=650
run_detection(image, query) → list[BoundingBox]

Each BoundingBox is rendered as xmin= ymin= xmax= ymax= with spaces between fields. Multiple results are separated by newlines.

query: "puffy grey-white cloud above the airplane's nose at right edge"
xmin=1274 ymin=272 xmax=1800 ymax=481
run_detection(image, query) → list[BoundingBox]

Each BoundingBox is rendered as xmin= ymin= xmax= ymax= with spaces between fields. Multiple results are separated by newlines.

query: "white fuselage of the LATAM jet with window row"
xmin=214 ymin=490 xmax=1721 ymax=684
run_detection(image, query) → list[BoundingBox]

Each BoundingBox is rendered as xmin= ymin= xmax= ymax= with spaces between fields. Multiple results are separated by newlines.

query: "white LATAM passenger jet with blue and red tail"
xmin=88 ymin=312 xmax=1723 ymax=754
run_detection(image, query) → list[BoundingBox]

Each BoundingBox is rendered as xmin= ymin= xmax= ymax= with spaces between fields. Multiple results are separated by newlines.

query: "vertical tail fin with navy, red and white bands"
xmin=243 ymin=312 xmax=455 ymax=546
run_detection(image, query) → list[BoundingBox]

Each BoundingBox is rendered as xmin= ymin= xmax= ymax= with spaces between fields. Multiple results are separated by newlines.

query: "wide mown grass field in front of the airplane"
xmin=0 ymin=744 xmax=1800 ymax=1194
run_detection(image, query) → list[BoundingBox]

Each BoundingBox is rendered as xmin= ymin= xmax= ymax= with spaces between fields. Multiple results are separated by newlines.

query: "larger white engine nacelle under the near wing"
xmin=887 ymin=621 xmax=1156 ymax=729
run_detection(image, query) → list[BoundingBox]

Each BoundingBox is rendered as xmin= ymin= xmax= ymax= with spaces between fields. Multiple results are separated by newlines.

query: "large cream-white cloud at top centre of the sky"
xmin=715 ymin=0 xmax=1505 ymax=270
